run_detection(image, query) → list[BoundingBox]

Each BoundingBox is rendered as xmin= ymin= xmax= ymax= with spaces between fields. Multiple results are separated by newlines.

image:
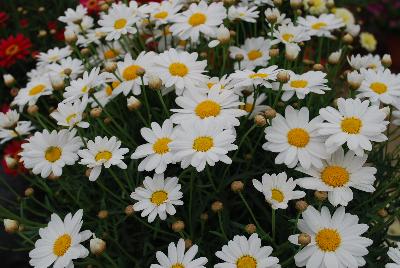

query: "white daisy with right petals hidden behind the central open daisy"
xmin=131 ymin=119 xmax=174 ymax=174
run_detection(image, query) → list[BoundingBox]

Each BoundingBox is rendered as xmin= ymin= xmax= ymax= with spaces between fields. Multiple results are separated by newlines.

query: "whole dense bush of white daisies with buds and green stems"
xmin=0 ymin=0 xmax=400 ymax=268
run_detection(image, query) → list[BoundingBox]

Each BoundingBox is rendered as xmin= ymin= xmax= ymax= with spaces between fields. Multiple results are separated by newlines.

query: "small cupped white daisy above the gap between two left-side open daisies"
xmin=50 ymin=100 xmax=89 ymax=129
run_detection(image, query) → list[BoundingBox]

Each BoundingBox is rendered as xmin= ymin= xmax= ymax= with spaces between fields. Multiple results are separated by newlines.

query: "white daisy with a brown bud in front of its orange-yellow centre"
xmin=113 ymin=51 xmax=156 ymax=96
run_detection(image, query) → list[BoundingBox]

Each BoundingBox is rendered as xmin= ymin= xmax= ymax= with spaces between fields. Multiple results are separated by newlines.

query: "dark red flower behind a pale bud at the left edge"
xmin=1 ymin=140 xmax=27 ymax=176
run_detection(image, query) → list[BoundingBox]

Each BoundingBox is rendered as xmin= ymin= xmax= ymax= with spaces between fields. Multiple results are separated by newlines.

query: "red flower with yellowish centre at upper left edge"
xmin=0 ymin=34 xmax=32 ymax=68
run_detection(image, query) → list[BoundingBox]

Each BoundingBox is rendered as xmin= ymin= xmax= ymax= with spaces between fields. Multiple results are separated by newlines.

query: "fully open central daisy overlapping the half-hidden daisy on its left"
xmin=169 ymin=120 xmax=238 ymax=172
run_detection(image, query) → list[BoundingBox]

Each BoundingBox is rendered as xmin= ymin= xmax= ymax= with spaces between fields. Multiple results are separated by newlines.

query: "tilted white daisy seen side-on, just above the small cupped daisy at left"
xmin=63 ymin=67 xmax=111 ymax=102
